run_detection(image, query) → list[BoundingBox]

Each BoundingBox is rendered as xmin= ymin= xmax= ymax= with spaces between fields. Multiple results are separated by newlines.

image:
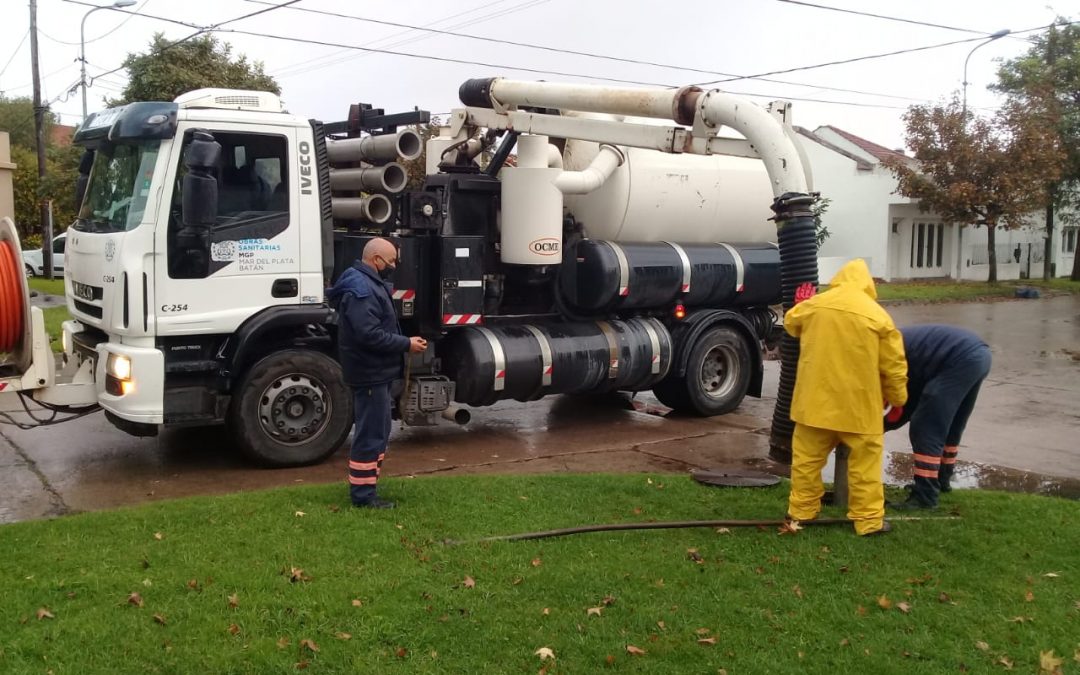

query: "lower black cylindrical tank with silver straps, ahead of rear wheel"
xmin=438 ymin=319 xmax=672 ymax=406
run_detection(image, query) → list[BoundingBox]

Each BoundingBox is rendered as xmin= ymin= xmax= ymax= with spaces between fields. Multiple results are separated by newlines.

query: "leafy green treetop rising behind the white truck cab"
xmin=107 ymin=32 xmax=281 ymax=106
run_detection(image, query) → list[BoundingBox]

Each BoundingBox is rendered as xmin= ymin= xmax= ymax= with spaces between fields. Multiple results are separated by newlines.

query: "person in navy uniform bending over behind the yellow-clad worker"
xmin=886 ymin=325 xmax=990 ymax=509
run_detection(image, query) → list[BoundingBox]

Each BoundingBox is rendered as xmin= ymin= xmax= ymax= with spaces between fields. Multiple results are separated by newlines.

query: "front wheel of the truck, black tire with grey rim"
xmin=228 ymin=350 xmax=353 ymax=468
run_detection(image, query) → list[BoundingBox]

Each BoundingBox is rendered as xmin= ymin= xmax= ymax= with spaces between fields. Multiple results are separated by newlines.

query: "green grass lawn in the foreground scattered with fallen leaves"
xmin=0 ymin=474 xmax=1080 ymax=674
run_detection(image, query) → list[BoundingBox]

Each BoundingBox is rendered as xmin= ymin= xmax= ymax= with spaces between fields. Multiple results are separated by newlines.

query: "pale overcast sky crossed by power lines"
xmin=0 ymin=0 xmax=1062 ymax=148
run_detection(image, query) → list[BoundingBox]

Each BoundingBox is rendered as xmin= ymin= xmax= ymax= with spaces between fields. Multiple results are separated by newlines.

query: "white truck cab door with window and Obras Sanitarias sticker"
xmin=151 ymin=123 xmax=300 ymax=337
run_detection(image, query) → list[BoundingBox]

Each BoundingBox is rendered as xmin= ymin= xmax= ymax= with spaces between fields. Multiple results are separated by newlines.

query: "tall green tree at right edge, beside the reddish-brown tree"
xmin=994 ymin=18 xmax=1080 ymax=281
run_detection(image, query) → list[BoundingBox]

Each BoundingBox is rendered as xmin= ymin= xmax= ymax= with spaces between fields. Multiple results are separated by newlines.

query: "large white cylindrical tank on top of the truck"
xmin=563 ymin=139 xmax=777 ymax=243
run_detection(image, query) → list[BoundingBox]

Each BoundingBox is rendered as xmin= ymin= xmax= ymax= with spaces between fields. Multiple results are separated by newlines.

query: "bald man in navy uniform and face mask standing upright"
xmin=326 ymin=239 xmax=428 ymax=509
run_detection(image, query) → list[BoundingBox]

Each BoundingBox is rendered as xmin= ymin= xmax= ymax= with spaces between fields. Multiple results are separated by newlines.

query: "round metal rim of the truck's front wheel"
xmin=259 ymin=373 xmax=333 ymax=445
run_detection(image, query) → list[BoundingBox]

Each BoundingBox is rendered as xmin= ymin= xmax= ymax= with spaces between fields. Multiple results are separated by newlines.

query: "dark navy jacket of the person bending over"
xmin=886 ymin=324 xmax=988 ymax=430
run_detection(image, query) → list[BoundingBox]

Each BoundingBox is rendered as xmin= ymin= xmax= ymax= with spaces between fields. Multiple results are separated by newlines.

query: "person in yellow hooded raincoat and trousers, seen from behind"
xmin=784 ymin=259 xmax=907 ymax=535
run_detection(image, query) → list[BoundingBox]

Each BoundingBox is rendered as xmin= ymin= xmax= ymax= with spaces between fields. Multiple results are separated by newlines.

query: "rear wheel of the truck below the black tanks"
xmin=652 ymin=326 xmax=752 ymax=417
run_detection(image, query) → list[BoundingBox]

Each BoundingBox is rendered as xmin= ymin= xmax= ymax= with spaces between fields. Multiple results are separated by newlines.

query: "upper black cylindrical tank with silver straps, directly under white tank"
xmin=559 ymin=240 xmax=780 ymax=313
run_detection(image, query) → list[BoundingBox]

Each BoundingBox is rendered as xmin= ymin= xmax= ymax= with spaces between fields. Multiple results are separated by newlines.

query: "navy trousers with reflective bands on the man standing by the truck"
xmin=349 ymin=382 xmax=390 ymax=504
